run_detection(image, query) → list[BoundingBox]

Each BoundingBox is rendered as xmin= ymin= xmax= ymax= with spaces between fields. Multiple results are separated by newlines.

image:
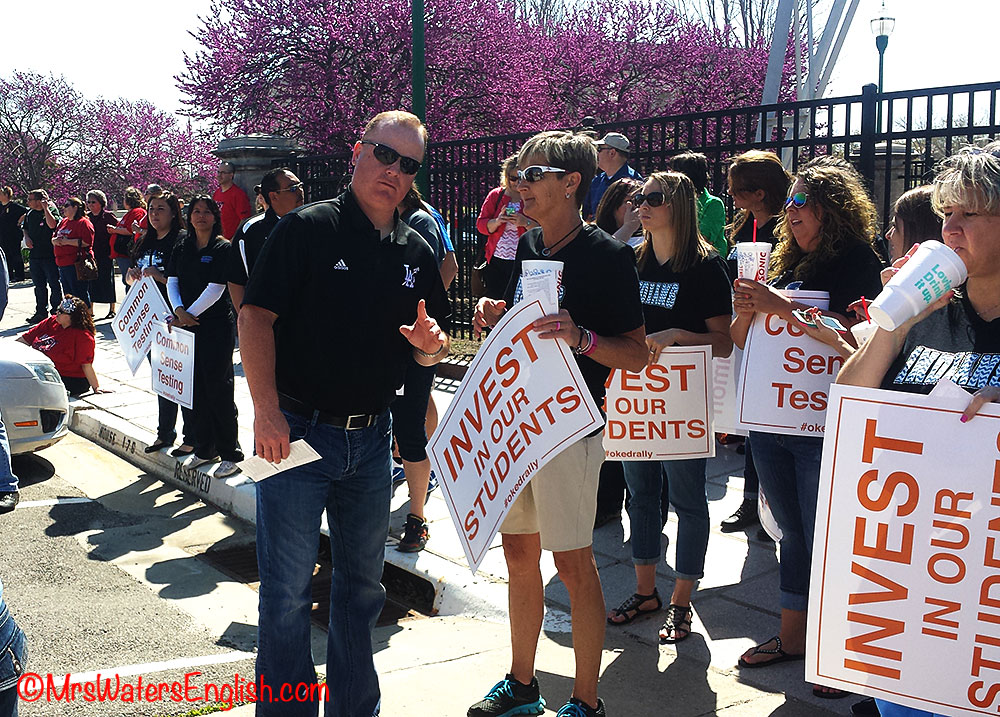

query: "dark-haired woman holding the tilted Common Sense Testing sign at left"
xmin=125 ymin=192 xmax=194 ymax=458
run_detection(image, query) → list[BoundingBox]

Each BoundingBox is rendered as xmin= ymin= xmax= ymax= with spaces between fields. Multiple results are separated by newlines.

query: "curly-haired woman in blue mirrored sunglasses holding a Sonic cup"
xmin=732 ymin=157 xmax=882 ymax=698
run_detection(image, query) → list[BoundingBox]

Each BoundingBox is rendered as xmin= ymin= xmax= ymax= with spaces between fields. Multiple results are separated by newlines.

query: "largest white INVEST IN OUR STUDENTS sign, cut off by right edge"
xmin=806 ymin=386 xmax=1000 ymax=716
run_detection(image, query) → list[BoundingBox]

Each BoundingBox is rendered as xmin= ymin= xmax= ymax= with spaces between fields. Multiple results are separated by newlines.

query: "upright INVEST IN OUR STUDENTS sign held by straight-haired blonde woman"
xmin=604 ymin=346 xmax=715 ymax=461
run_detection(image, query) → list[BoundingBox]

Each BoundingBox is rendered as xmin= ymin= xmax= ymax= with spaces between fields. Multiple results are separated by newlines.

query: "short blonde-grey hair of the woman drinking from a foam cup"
xmin=931 ymin=142 xmax=1000 ymax=215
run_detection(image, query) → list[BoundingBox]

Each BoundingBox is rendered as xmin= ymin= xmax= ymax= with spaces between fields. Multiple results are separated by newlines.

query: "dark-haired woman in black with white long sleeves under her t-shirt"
xmin=166 ymin=195 xmax=243 ymax=478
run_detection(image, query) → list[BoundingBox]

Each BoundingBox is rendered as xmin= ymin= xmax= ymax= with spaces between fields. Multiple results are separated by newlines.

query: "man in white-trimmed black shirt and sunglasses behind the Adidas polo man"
xmin=226 ymin=167 xmax=305 ymax=311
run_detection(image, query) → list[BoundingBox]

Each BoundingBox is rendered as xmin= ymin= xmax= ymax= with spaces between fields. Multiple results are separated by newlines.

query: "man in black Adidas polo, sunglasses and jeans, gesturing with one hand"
xmin=239 ymin=107 xmax=449 ymax=717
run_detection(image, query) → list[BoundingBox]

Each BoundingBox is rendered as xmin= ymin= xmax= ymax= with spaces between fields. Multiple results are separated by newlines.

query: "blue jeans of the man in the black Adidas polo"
xmin=257 ymin=411 xmax=392 ymax=717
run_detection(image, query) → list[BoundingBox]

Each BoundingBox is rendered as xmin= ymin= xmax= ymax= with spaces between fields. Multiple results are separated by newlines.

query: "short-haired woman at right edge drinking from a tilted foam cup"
xmin=837 ymin=142 xmax=1000 ymax=717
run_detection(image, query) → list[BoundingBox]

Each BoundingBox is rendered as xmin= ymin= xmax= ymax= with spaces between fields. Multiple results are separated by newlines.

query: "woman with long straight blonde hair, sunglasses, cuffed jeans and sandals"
xmin=608 ymin=172 xmax=733 ymax=643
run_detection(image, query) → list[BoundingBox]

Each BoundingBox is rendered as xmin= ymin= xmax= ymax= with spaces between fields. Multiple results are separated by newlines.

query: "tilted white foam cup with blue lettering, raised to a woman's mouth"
xmin=868 ymin=239 xmax=968 ymax=331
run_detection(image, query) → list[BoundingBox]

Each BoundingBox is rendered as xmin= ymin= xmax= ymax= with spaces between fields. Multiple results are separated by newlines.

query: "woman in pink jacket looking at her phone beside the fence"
xmin=476 ymin=154 xmax=537 ymax=299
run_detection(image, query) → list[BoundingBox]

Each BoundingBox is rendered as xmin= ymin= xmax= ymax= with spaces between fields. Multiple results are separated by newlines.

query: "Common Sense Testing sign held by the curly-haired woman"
xmin=737 ymin=291 xmax=844 ymax=436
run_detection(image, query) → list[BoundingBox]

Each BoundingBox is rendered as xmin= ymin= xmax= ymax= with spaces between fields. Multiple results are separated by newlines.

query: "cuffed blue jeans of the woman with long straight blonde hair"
xmin=622 ymin=458 xmax=709 ymax=580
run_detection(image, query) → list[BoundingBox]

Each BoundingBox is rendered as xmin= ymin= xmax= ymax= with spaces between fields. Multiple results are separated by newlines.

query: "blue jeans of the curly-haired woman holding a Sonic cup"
xmin=750 ymin=431 xmax=823 ymax=611
